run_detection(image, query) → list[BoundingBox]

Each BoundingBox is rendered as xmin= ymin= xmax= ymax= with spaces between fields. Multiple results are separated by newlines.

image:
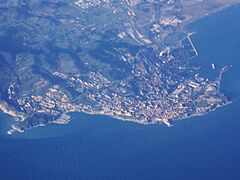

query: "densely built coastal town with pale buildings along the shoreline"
xmin=0 ymin=37 xmax=231 ymax=134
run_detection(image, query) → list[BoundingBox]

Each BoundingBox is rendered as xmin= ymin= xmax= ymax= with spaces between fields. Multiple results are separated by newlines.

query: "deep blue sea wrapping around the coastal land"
xmin=0 ymin=6 xmax=240 ymax=180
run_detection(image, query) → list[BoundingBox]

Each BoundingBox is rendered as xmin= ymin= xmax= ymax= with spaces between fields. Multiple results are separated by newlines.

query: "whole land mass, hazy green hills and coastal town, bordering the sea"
xmin=0 ymin=0 xmax=235 ymax=134
